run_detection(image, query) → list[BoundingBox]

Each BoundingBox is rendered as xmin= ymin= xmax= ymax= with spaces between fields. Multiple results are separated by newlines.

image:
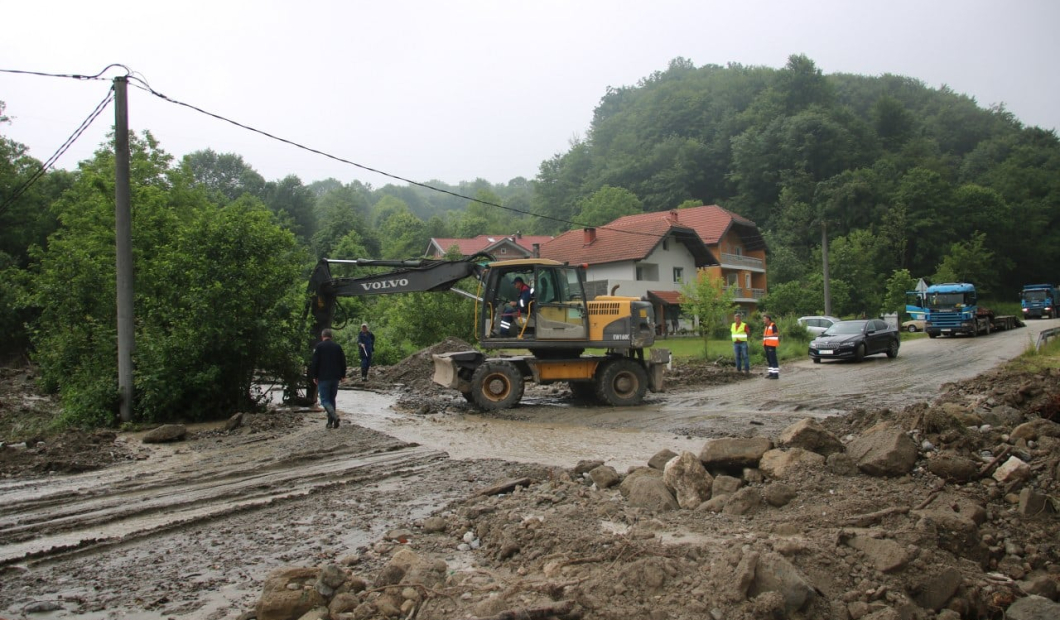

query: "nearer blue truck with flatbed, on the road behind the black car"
xmin=924 ymin=282 xmax=1017 ymax=338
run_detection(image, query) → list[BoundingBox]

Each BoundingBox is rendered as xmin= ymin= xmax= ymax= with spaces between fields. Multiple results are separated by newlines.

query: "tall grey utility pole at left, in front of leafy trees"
xmin=114 ymin=76 xmax=135 ymax=422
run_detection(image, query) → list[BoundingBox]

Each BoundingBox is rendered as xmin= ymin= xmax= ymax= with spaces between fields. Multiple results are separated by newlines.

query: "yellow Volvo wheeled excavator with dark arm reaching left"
xmin=298 ymin=254 xmax=670 ymax=410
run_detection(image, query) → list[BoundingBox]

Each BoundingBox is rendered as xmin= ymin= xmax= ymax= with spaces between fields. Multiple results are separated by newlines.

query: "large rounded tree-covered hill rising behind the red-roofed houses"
xmin=533 ymin=56 xmax=1060 ymax=311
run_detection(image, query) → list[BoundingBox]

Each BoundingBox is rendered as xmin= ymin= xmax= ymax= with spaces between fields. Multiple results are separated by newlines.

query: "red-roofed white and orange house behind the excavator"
xmin=541 ymin=205 xmax=766 ymax=330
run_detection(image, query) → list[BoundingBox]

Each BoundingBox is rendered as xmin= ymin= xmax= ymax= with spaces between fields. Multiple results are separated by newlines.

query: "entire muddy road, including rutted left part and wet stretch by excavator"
xmin=0 ymin=321 xmax=1060 ymax=619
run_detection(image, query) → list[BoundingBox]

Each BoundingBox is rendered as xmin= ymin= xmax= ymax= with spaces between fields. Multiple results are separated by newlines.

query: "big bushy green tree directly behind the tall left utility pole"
xmin=32 ymin=132 xmax=305 ymax=425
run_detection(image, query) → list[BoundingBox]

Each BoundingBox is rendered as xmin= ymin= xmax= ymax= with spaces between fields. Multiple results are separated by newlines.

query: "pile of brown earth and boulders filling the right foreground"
xmin=246 ymin=371 xmax=1060 ymax=620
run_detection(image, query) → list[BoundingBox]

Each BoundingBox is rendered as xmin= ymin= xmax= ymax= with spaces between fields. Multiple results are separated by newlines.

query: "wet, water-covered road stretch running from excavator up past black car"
xmin=339 ymin=320 xmax=1047 ymax=470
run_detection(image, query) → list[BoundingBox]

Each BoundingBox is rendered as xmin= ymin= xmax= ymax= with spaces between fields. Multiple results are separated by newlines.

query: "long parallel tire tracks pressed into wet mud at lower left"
xmin=0 ymin=444 xmax=447 ymax=566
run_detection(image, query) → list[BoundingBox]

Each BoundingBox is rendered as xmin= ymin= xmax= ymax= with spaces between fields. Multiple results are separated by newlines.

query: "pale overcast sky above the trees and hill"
xmin=0 ymin=0 xmax=1060 ymax=187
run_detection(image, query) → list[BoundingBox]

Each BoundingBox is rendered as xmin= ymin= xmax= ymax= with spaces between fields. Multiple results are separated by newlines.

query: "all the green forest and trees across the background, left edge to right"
xmin=0 ymin=55 xmax=1060 ymax=425
